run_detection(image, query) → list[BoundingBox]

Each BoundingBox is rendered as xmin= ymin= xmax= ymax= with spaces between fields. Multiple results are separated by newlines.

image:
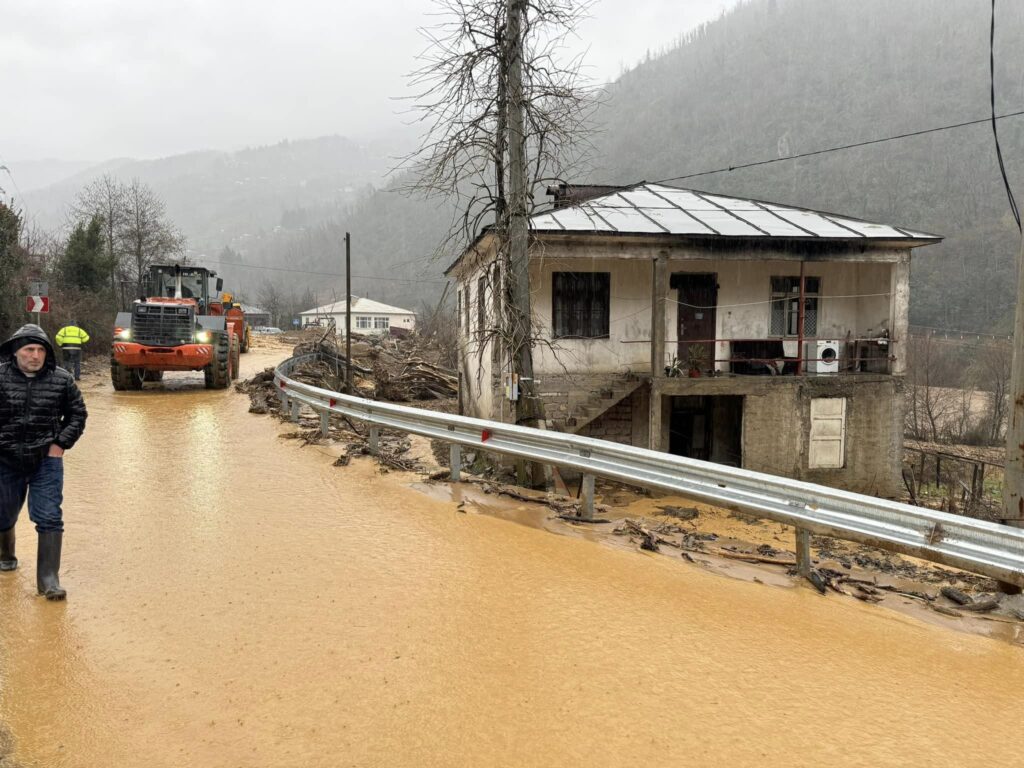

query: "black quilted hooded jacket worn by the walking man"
xmin=0 ymin=324 xmax=88 ymax=472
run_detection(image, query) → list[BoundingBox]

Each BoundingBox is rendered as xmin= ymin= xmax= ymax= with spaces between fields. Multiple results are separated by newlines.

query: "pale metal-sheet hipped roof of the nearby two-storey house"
xmin=529 ymin=183 xmax=942 ymax=242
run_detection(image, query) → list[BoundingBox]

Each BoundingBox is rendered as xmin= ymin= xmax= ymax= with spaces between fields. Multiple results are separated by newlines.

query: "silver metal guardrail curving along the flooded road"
xmin=274 ymin=354 xmax=1024 ymax=587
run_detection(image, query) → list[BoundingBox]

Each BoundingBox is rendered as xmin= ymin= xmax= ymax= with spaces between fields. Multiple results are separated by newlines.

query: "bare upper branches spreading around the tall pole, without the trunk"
xmin=400 ymin=0 xmax=595 ymax=250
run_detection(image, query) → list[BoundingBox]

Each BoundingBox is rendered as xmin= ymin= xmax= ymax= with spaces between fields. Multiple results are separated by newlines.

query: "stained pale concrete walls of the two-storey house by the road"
xmin=457 ymin=237 xmax=909 ymax=496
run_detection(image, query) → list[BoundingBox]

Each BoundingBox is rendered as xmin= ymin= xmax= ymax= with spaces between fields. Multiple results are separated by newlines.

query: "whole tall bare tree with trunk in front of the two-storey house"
xmin=402 ymin=0 xmax=594 ymax=462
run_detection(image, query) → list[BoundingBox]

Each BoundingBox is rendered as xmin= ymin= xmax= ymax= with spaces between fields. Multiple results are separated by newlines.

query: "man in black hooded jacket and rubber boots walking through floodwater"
xmin=0 ymin=325 xmax=87 ymax=600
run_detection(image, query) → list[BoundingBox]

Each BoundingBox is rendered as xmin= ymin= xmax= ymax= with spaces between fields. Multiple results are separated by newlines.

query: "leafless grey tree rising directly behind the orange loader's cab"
xmin=118 ymin=179 xmax=184 ymax=295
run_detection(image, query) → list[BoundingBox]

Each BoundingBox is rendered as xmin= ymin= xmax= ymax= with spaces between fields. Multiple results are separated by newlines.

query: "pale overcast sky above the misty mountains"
xmin=0 ymin=0 xmax=738 ymax=162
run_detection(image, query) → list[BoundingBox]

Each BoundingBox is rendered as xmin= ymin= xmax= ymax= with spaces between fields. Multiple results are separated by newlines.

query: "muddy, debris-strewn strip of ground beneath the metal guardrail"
xmin=247 ymin=354 xmax=1024 ymax=644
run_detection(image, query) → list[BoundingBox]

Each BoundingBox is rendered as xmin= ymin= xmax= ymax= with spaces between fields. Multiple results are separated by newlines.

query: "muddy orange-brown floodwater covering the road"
xmin=0 ymin=352 xmax=1024 ymax=768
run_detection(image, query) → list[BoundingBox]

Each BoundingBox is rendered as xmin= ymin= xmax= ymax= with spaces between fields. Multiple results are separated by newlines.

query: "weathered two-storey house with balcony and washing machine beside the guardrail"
xmin=446 ymin=183 xmax=941 ymax=495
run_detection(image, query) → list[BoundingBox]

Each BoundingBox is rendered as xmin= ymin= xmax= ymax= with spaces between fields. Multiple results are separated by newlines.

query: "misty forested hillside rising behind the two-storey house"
xmin=594 ymin=0 xmax=1024 ymax=330
